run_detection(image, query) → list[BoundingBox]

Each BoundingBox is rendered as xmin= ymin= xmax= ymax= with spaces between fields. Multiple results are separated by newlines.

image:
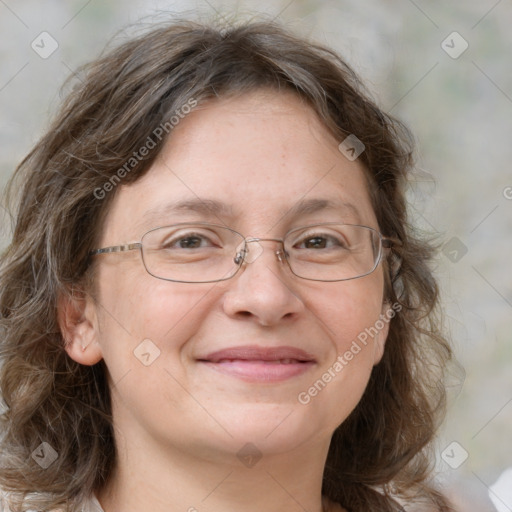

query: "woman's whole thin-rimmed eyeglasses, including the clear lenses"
xmin=89 ymin=222 xmax=393 ymax=283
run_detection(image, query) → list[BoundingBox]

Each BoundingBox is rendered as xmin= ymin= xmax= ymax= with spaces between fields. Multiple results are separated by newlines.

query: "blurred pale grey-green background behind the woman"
xmin=0 ymin=0 xmax=512 ymax=512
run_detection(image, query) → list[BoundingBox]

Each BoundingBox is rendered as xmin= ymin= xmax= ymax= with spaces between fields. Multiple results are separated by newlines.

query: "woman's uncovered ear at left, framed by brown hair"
xmin=57 ymin=288 xmax=103 ymax=366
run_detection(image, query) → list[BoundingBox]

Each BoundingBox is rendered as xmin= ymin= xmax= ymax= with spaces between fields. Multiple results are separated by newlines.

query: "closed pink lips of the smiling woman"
xmin=198 ymin=345 xmax=316 ymax=382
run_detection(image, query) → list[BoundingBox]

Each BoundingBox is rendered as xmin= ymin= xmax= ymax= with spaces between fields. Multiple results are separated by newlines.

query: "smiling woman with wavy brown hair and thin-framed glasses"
xmin=0 ymin=17 xmax=451 ymax=512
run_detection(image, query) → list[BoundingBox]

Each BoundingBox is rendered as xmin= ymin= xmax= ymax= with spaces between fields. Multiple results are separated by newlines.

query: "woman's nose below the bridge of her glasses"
xmin=223 ymin=238 xmax=304 ymax=326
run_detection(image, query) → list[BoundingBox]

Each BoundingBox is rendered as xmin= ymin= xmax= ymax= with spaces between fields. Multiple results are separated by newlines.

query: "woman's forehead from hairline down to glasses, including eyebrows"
xmin=100 ymin=91 xmax=376 ymax=241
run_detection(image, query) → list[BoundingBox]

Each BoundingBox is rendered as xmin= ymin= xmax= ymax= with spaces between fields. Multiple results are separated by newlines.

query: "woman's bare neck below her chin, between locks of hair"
xmin=97 ymin=428 xmax=328 ymax=512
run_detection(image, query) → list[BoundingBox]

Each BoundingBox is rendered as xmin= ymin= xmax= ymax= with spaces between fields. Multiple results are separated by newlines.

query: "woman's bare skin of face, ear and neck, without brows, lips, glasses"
xmin=59 ymin=91 xmax=387 ymax=512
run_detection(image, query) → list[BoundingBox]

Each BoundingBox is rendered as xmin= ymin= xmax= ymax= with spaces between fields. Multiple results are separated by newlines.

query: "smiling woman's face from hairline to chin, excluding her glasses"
xmin=67 ymin=92 xmax=387 ymax=457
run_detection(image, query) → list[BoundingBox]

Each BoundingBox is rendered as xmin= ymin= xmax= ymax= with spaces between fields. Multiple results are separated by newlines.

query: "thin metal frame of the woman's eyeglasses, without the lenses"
xmin=89 ymin=222 xmax=401 ymax=284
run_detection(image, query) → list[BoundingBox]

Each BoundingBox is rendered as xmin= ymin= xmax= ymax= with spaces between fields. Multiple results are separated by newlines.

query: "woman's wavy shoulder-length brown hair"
xmin=0 ymin=16 xmax=451 ymax=512
